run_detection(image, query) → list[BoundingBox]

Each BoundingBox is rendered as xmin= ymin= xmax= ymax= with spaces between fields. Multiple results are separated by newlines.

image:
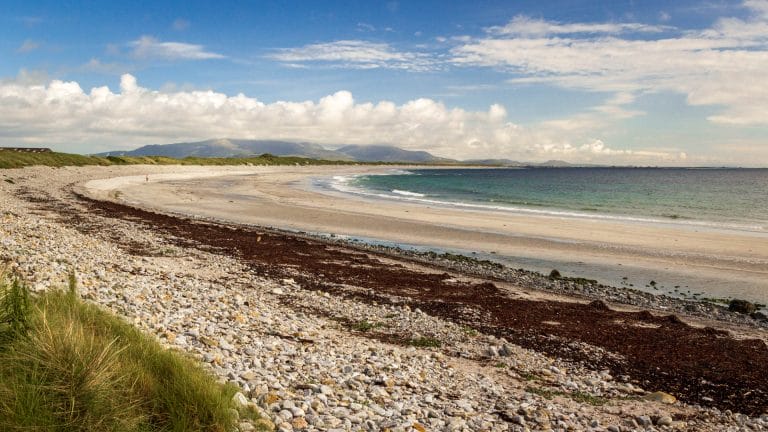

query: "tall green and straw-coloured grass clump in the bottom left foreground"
xmin=0 ymin=275 xmax=262 ymax=432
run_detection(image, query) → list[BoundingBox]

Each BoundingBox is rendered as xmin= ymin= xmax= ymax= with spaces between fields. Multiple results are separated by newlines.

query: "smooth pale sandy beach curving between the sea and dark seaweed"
xmin=91 ymin=166 xmax=768 ymax=303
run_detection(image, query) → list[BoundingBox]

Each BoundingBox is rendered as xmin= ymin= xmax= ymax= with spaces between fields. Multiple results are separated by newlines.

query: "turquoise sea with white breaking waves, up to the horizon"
xmin=332 ymin=168 xmax=768 ymax=232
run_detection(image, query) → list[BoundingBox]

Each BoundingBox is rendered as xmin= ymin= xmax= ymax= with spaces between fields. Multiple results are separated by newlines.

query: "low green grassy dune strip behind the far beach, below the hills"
xmin=0 ymin=149 xmax=357 ymax=168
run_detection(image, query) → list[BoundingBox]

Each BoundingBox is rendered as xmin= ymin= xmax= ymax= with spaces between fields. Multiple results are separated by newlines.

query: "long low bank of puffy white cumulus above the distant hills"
xmin=0 ymin=74 xmax=679 ymax=164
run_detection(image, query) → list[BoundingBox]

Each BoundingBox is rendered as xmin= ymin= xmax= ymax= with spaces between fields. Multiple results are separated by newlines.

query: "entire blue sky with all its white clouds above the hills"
xmin=0 ymin=0 xmax=768 ymax=166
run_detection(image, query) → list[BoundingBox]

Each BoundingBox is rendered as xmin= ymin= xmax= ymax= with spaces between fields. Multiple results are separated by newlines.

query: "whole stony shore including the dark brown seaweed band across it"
xmin=0 ymin=167 xmax=768 ymax=431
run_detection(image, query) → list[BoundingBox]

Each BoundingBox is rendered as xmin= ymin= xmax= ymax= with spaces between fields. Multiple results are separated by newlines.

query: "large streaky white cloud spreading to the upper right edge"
xmin=452 ymin=0 xmax=768 ymax=125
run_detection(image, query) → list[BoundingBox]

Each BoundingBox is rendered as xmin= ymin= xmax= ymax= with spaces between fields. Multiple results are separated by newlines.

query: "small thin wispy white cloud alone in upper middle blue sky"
xmin=269 ymin=40 xmax=438 ymax=71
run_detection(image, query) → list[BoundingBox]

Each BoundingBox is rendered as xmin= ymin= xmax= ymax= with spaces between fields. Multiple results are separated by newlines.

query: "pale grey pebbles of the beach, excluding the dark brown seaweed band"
xmin=0 ymin=166 xmax=768 ymax=432
